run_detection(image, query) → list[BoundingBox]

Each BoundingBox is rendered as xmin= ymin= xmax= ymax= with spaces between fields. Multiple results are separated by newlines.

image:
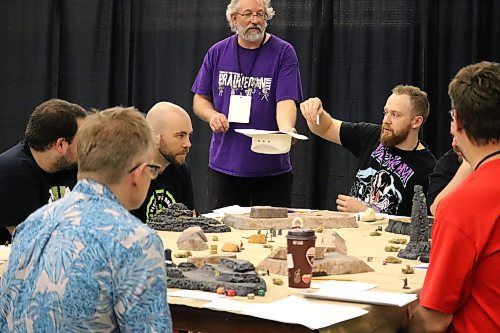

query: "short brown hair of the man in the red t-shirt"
xmin=448 ymin=61 xmax=500 ymax=146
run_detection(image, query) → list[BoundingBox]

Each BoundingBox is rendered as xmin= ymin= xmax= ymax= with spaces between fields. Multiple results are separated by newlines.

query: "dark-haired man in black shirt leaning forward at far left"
xmin=0 ymin=99 xmax=87 ymax=242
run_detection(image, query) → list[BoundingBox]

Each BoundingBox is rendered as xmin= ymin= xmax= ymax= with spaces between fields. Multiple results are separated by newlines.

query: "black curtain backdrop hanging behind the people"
xmin=0 ymin=0 xmax=500 ymax=212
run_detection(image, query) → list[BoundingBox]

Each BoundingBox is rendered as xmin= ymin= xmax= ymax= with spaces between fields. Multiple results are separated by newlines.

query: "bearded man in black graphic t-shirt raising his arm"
xmin=300 ymin=85 xmax=436 ymax=216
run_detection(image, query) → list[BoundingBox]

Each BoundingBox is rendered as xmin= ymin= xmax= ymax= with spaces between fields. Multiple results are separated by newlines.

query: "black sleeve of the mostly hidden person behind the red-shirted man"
xmin=427 ymin=149 xmax=460 ymax=207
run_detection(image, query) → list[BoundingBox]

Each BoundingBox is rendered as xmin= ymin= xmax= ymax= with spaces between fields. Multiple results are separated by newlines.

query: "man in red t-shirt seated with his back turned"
xmin=409 ymin=61 xmax=500 ymax=333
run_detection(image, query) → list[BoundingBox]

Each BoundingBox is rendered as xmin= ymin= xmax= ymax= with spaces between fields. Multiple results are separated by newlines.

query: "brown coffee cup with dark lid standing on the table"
xmin=286 ymin=229 xmax=316 ymax=288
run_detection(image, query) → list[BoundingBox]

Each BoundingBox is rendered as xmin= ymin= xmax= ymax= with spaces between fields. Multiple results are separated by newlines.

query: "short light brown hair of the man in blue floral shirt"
xmin=77 ymin=106 xmax=154 ymax=183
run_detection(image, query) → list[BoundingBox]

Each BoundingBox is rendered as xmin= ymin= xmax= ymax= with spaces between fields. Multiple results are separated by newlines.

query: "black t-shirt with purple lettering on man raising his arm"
xmin=340 ymin=122 xmax=436 ymax=216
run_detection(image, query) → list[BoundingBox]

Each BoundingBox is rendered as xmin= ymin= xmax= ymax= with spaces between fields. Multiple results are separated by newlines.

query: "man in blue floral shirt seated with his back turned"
xmin=0 ymin=107 xmax=172 ymax=332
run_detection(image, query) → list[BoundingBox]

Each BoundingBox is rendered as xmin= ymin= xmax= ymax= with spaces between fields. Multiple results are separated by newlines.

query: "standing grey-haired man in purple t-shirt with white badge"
xmin=191 ymin=0 xmax=302 ymax=210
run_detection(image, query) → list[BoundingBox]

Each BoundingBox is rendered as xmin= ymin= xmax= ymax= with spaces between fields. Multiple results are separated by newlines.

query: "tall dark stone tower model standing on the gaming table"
xmin=398 ymin=185 xmax=431 ymax=262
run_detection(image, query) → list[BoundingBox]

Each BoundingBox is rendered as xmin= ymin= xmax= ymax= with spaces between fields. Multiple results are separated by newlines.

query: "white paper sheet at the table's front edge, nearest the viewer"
xmin=204 ymin=296 xmax=368 ymax=330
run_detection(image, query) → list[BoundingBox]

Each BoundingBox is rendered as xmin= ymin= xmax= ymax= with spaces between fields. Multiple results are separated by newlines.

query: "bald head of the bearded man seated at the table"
xmin=146 ymin=102 xmax=193 ymax=164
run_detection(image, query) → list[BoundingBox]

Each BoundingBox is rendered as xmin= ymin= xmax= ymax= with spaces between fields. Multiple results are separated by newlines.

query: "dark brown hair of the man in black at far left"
xmin=24 ymin=98 xmax=87 ymax=151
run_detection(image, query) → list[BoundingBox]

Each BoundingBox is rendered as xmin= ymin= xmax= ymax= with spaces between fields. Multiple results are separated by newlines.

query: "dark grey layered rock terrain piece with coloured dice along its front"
xmin=167 ymin=258 xmax=266 ymax=296
